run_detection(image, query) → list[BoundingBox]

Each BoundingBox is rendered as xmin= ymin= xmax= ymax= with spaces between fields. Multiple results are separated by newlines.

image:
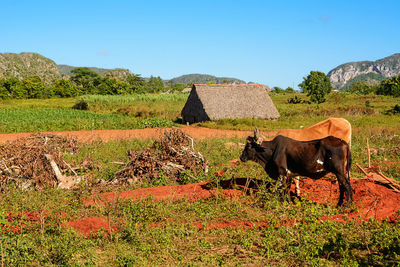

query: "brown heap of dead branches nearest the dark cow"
xmin=110 ymin=129 xmax=208 ymax=185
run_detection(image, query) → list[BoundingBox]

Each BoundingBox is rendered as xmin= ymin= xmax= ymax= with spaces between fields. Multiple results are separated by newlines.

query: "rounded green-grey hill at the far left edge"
xmin=0 ymin=53 xmax=61 ymax=84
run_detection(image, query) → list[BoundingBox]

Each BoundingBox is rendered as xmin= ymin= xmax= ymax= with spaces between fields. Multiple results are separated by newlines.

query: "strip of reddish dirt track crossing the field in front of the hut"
xmin=0 ymin=126 xmax=256 ymax=143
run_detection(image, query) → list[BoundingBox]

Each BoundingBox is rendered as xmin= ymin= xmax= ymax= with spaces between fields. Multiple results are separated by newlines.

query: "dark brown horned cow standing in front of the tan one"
xmin=240 ymin=129 xmax=353 ymax=206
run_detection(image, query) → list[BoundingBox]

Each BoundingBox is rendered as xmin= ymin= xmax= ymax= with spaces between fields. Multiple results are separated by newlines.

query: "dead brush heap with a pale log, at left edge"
xmin=0 ymin=133 xmax=78 ymax=189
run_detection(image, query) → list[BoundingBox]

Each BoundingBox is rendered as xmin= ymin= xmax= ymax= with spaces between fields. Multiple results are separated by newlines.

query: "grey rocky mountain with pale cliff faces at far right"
xmin=328 ymin=53 xmax=400 ymax=89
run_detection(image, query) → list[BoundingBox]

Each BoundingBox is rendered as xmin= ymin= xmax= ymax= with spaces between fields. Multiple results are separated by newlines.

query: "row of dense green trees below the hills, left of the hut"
xmin=0 ymin=67 xmax=188 ymax=99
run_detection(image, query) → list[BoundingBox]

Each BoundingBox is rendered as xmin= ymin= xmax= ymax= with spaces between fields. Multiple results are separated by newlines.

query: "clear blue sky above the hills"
xmin=0 ymin=0 xmax=400 ymax=88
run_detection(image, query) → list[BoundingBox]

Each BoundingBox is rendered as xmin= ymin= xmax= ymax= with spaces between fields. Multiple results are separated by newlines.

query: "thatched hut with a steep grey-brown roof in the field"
xmin=181 ymin=84 xmax=279 ymax=123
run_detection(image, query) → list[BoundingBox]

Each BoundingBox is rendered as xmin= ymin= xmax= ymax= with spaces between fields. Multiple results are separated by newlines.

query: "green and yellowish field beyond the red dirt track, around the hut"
xmin=0 ymin=93 xmax=399 ymax=135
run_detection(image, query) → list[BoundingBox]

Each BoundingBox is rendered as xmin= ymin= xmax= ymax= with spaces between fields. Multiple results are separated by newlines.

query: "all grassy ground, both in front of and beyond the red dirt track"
xmin=0 ymin=92 xmax=400 ymax=266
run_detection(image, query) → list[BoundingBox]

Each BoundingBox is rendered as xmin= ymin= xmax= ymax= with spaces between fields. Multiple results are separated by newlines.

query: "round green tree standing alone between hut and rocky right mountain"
xmin=299 ymin=71 xmax=332 ymax=104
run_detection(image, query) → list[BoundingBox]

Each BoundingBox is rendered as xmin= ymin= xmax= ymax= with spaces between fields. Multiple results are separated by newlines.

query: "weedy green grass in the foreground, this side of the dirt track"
xmin=0 ymin=130 xmax=400 ymax=266
